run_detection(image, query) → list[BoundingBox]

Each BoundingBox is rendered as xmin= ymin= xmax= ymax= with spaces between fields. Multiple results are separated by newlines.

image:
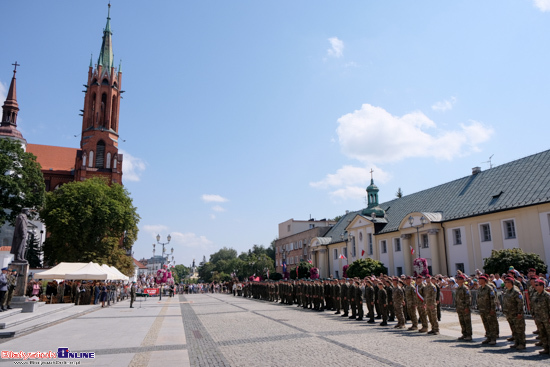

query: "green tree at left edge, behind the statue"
xmin=0 ymin=138 xmax=46 ymax=227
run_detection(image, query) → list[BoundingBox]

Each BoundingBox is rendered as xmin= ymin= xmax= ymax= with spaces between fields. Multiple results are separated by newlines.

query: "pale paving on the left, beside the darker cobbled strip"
xmin=0 ymin=297 xmax=190 ymax=367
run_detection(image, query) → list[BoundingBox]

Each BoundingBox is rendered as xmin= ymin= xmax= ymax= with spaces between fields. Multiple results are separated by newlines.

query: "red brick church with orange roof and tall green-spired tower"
xmin=0 ymin=5 xmax=123 ymax=191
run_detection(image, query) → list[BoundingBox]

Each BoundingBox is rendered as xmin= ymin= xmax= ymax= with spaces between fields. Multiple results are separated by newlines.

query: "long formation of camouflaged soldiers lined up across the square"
xmin=227 ymin=267 xmax=550 ymax=354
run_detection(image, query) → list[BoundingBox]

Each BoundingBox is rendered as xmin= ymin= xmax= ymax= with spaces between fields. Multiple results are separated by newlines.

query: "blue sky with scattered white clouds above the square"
xmin=0 ymin=0 xmax=550 ymax=266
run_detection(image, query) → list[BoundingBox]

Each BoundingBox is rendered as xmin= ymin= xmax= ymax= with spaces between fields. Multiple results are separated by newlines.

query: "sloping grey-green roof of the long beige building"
xmin=378 ymin=150 xmax=550 ymax=233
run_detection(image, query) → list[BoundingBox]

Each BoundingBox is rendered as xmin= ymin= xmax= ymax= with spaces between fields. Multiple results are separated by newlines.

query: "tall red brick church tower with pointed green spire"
xmin=75 ymin=4 xmax=123 ymax=184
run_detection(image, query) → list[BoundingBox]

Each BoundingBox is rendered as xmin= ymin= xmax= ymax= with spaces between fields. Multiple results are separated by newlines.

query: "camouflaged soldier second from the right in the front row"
xmin=504 ymin=277 xmax=525 ymax=350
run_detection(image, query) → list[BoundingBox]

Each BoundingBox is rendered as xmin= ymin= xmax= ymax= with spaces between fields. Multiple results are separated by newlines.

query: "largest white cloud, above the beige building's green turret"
xmin=337 ymin=104 xmax=494 ymax=164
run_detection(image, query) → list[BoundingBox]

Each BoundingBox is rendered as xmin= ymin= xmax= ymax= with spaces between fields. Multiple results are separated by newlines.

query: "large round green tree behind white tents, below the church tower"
xmin=40 ymin=177 xmax=140 ymax=275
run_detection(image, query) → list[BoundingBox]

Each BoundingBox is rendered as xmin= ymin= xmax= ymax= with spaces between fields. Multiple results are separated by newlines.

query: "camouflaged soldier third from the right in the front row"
xmin=477 ymin=275 xmax=499 ymax=345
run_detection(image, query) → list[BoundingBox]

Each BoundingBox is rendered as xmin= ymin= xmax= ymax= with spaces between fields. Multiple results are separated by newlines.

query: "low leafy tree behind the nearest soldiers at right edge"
xmin=483 ymin=248 xmax=548 ymax=274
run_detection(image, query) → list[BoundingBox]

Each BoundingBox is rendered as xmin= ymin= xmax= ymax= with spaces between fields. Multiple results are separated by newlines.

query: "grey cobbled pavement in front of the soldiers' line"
xmin=184 ymin=294 xmax=549 ymax=367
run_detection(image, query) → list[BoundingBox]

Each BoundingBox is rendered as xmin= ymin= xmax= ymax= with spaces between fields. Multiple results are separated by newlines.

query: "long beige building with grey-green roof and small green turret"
xmin=309 ymin=151 xmax=550 ymax=277
